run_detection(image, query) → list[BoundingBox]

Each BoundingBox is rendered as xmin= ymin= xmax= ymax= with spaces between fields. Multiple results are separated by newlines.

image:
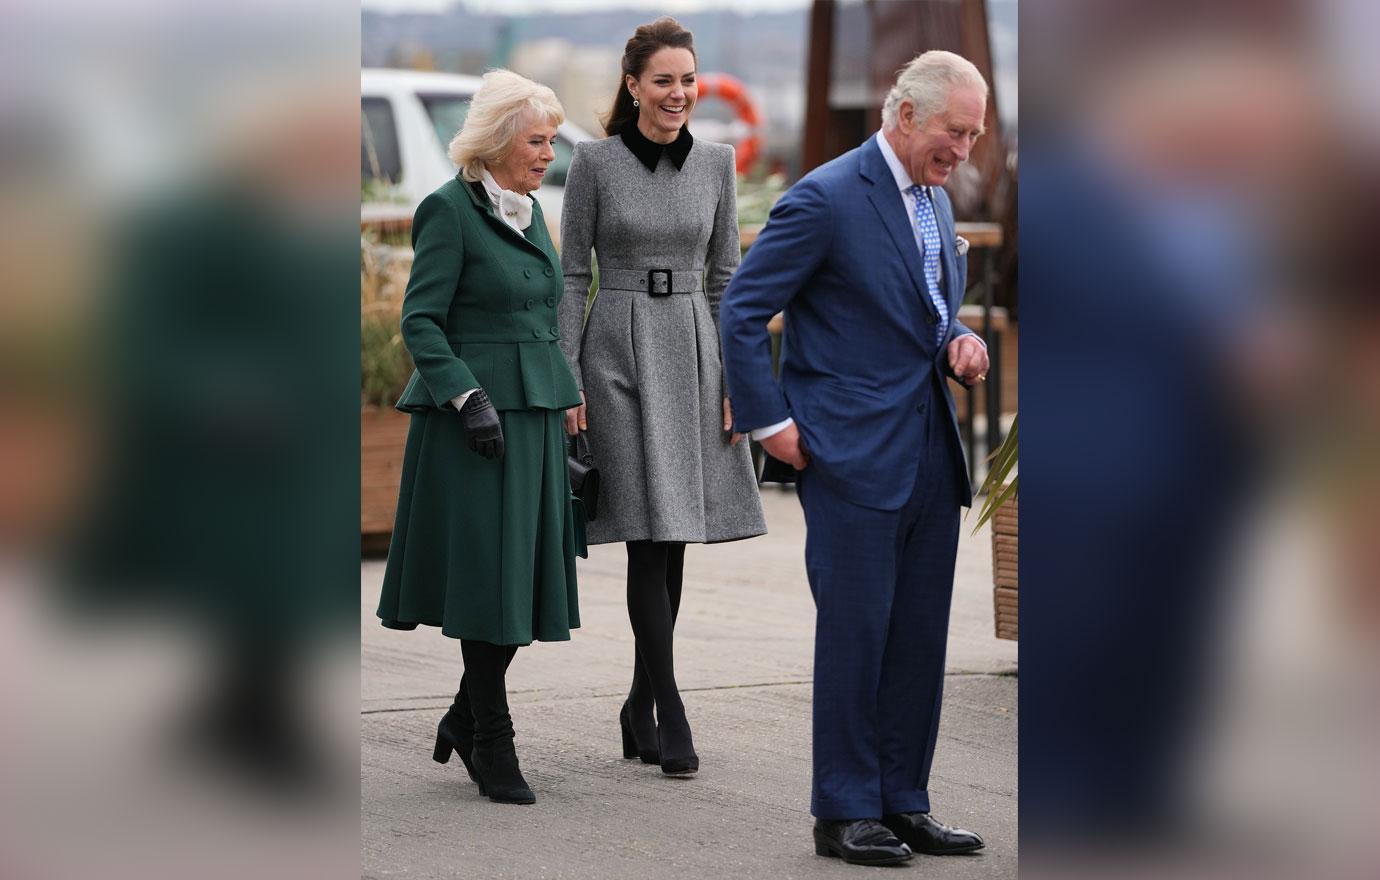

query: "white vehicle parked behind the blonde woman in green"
xmin=359 ymin=68 xmax=589 ymax=241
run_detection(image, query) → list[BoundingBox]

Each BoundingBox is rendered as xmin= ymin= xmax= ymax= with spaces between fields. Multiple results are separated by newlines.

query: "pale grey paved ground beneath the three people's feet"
xmin=360 ymin=488 xmax=1017 ymax=880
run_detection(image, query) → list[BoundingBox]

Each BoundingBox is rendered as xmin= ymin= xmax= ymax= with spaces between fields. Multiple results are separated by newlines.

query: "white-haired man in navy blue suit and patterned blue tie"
xmin=719 ymin=51 xmax=988 ymax=865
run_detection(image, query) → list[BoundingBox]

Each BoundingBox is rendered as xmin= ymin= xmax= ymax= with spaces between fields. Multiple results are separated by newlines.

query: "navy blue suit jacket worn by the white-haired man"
xmin=719 ymin=137 xmax=973 ymax=510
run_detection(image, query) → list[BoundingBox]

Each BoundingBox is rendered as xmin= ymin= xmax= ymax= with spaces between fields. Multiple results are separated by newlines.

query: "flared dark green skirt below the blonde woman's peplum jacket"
xmin=378 ymin=410 xmax=587 ymax=644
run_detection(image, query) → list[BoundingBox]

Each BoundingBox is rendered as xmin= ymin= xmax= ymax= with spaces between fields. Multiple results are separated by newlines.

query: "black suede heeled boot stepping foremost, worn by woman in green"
xmin=460 ymin=639 xmax=537 ymax=804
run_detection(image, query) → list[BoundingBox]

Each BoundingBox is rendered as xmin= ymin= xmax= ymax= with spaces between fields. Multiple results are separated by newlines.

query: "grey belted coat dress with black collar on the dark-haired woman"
xmin=559 ymin=131 xmax=766 ymax=543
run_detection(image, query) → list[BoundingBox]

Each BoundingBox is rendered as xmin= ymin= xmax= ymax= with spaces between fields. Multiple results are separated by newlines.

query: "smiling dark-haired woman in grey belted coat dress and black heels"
xmin=560 ymin=18 xmax=766 ymax=775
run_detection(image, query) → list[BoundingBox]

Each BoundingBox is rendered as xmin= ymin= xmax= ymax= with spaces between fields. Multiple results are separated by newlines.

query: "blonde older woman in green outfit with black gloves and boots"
xmin=378 ymin=70 xmax=585 ymax=803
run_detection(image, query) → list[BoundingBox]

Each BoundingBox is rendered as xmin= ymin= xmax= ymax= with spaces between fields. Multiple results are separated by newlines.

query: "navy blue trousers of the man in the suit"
xmin=799 ymin=400 xmax=962 ymax=819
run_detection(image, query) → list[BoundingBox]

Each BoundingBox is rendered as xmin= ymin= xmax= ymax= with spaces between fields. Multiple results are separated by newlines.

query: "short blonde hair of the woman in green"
xmin=447 ymin=69 xmax=566 ymax=182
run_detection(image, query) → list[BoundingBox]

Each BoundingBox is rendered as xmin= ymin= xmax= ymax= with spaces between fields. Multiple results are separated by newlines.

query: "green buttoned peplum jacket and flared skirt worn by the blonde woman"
xmin=378 ymin=177 xmax=585 ymax=644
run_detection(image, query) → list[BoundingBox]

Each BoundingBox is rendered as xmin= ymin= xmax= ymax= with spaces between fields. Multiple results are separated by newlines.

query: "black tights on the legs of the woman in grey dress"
xmin=628 ymin=541 xmax=689 ymax=752
